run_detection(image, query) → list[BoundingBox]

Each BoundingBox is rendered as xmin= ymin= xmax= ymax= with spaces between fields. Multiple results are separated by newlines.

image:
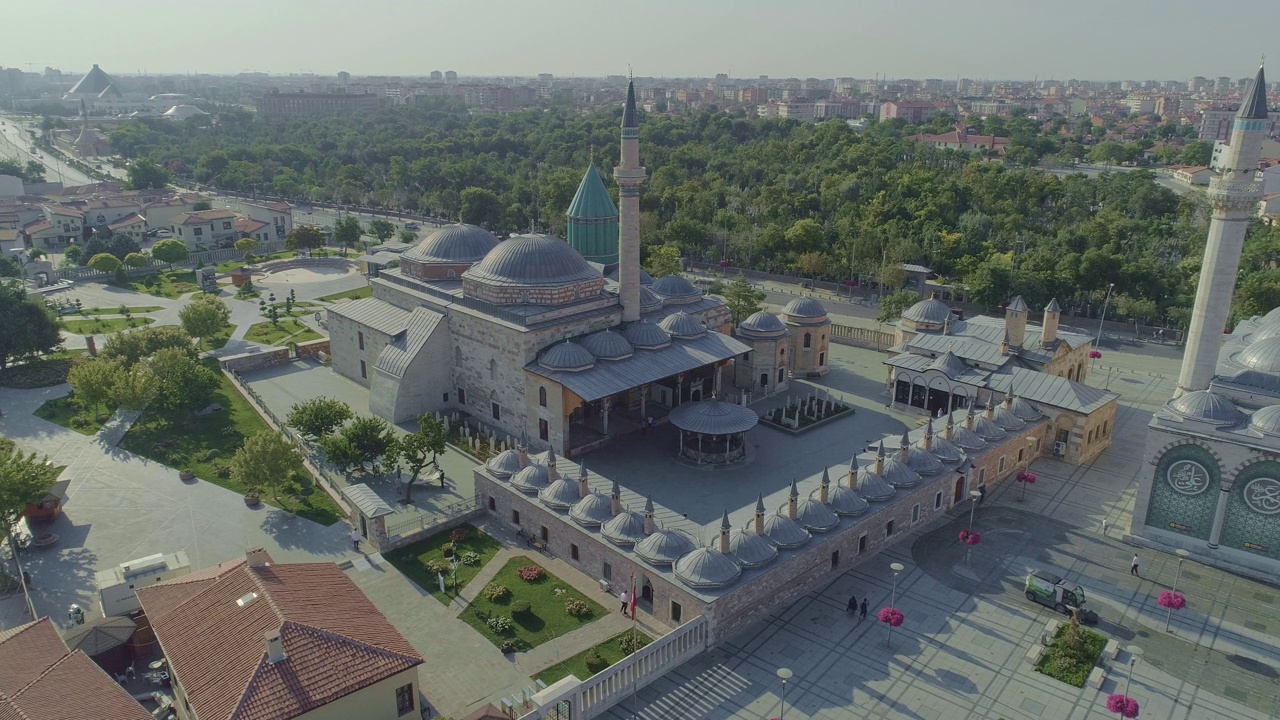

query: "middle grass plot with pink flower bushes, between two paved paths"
xmin=458 ymin=557 xmax=605 ymax=651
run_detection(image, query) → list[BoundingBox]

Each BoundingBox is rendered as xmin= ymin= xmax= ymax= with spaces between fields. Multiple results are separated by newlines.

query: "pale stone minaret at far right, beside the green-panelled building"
xmin=1175 ymin=65 xmax=1267 ymax=397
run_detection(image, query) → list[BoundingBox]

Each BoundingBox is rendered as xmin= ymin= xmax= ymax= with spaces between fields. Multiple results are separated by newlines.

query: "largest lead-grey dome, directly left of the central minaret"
xmin=462 ymin=234 xmax=600 ymax=287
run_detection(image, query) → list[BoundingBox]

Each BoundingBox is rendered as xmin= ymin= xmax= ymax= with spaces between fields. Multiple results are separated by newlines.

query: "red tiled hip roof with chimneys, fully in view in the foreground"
xmin=138 ymin=550 xmax=422 ymax=720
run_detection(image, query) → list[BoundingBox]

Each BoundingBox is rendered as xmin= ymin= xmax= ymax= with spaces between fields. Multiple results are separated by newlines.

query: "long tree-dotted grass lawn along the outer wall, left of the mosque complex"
xmin=120 ymin=357 xmax=344 ymax=525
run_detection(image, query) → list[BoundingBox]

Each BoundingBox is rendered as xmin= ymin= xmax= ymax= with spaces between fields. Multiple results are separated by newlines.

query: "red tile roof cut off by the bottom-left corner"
xmin=0 ymin=618 xmax=151 ymax=720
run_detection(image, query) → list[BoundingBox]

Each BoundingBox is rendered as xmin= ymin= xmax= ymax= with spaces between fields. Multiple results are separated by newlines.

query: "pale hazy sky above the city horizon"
xmin=0 ymin=0 xmax=1280 ymax=79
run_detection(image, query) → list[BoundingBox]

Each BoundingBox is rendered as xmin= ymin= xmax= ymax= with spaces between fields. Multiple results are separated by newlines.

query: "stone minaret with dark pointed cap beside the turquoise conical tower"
xmin=613 ymin=79 xmax=645 ymax=323
